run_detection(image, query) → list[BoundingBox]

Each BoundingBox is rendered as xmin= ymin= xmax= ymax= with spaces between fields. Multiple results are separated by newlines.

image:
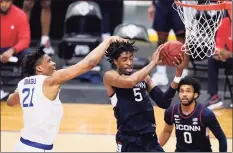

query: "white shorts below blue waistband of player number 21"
xmin=14 ymin=141 xmax=53 ymax=152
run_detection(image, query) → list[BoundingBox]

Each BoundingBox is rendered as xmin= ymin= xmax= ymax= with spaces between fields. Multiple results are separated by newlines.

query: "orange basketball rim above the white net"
xmin=175 ymin=0 xmax=232 ymax=11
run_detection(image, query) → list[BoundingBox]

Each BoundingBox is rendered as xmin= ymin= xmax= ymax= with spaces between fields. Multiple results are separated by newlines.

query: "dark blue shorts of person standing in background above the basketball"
xmin=153 ymin=3 xmax=185 ymax=34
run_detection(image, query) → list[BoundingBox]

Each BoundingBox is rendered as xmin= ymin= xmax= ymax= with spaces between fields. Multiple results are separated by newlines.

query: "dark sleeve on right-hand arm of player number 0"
xmin=202 ymin=108 xmax=227 ymax=152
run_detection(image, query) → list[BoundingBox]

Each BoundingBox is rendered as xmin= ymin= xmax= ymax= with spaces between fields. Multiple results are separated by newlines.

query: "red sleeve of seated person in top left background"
xmin=13 ymin=13 xmax=31 ymax=53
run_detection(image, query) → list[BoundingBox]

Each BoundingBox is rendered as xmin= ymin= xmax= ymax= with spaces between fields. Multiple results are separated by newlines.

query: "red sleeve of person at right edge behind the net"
xmin=216 ymin=19 xmax=228 ymax=48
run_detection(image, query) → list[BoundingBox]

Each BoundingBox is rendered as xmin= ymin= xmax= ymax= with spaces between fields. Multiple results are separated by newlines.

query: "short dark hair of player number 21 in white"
xmin=22 ymin=46 xmax=45 ymax=76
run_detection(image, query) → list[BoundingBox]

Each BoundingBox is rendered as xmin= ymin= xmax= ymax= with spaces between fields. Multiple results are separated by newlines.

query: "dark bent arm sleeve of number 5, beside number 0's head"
xmin=149 ymin=86 xmax=176 ymax=109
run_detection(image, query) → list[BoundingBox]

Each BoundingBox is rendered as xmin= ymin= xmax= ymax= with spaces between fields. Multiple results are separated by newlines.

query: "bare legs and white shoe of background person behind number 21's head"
xmin=23 ymin=0 xmax=54 ymax=55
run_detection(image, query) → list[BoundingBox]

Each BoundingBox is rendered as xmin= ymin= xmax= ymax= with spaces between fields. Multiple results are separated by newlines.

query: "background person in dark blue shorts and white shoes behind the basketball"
xmin=148 ymin=0 xmax=188 ymax=86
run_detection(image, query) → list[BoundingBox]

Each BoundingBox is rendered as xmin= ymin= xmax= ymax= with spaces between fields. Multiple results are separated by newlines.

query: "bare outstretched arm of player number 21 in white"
xmin=45 ymin=36 xmax=127 ymax=85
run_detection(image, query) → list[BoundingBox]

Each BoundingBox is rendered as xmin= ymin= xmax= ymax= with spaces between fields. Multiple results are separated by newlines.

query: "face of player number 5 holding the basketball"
xmin=114 ymin=52 xmax=133 ymax=75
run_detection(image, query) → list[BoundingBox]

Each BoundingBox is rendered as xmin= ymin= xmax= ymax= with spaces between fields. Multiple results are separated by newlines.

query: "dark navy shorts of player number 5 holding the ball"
xmin=116 ymin=133 xmax=164 ymax=152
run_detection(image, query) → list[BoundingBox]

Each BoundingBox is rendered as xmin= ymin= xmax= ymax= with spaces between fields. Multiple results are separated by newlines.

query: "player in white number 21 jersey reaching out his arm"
xmin=7 ymin=36 xmax=126 ymax=152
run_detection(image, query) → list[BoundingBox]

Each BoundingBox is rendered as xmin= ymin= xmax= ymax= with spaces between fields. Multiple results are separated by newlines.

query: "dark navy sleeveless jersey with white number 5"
xmin=111 ymin=81 xmax=155 ymax=134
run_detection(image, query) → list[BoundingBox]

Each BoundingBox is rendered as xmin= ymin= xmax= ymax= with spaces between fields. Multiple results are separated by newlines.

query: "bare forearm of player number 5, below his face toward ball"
xmin=129 ymin=61 xmax=156 ymax=86
